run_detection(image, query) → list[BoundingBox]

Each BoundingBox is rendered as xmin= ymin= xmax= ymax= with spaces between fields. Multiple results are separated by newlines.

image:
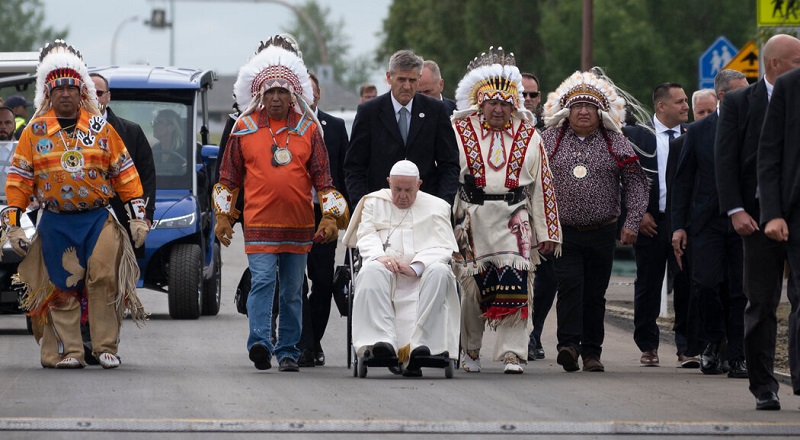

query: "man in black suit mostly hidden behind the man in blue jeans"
xmin=297 ymin=73 xmax=348 ymax=367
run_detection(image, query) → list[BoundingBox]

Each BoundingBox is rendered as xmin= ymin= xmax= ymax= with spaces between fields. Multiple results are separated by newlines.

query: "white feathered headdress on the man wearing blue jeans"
xmin=233 ymin=34 xmax=314 ymax=122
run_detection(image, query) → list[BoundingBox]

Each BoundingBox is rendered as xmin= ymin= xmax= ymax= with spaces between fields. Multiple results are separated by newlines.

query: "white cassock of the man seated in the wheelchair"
xmin=343 ymin=189 xmax=461 ymax=362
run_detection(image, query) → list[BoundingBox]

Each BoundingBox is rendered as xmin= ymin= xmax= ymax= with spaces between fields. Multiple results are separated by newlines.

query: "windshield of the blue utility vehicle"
xmin=109 ymin=100 xmax=194 ymax=189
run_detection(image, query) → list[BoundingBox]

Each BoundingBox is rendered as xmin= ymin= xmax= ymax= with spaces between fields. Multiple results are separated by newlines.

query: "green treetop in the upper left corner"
xmin=0 ymin=0 xmax=67 ymax=52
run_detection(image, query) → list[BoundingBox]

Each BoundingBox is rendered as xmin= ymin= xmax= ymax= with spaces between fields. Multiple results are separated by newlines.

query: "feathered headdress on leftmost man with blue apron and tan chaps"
xmin=33 ymin=40 xmax=100 ymax=117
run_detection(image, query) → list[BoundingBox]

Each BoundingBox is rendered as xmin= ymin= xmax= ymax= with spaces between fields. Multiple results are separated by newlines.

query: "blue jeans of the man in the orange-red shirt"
xmin=247 ymin=252 xmax=308 ymax=362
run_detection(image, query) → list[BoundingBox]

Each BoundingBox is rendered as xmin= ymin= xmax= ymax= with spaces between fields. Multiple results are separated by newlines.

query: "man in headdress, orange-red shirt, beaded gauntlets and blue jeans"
xmin=213 ymin=35 xmax=347 ymax=371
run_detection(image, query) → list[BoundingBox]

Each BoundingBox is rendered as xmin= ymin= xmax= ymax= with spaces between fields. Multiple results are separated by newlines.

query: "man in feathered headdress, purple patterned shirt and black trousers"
xmin=542 ymin=72 xmax=649 ymax=372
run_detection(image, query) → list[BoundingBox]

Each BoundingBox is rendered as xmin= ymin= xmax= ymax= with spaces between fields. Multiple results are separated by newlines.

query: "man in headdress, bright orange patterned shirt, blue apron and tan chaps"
xmin=1 ymin=40 xmax=149 ymax=368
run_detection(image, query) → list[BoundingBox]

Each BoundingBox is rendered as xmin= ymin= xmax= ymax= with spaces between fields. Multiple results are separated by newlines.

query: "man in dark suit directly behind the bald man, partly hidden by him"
xmin=671 ymin=69 xmax=747 ymax=378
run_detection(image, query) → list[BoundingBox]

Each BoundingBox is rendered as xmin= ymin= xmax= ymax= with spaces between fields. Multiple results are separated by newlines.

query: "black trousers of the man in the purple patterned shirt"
xmin=553 ymin=223 xmax=617 ymax=359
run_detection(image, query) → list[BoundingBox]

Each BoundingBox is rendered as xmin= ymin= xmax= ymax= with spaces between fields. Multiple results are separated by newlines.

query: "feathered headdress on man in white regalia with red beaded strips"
xmin=453 ymin=47 xmax=533 ymax=121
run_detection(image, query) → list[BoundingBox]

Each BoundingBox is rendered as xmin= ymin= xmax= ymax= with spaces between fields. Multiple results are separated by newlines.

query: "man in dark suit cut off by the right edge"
xmin=758 ymin=64 xmax=800 ymax=410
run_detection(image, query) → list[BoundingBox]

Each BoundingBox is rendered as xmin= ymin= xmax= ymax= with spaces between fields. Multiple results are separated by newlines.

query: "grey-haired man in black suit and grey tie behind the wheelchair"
xmin=344 ymin=50 xmax=460 ymax=205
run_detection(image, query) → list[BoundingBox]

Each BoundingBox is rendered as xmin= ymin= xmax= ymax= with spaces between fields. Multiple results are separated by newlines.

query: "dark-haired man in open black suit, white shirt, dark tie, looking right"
xmin=624 ymin=83 xmax=689 ymax=366
